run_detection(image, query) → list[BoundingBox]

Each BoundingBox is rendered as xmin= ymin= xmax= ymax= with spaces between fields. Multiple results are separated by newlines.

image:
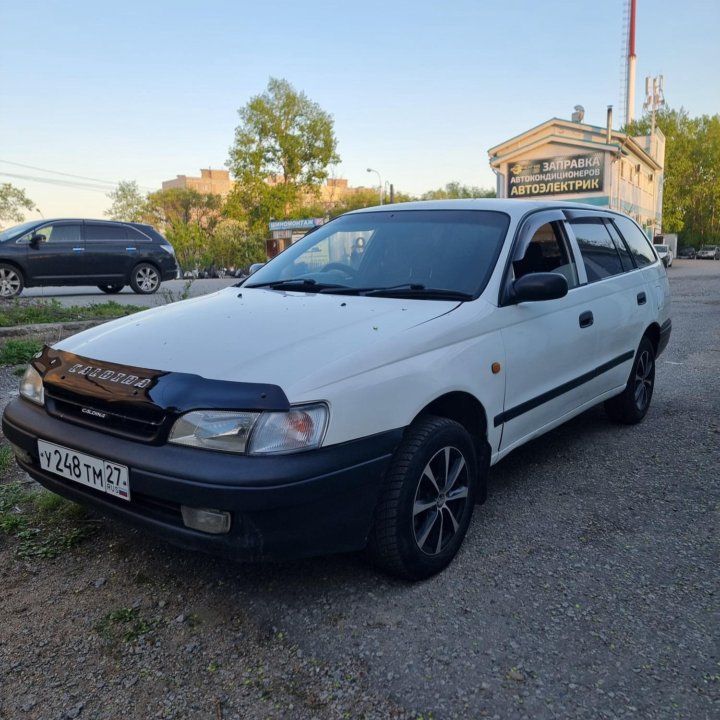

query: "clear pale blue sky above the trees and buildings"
xmin=0 ymin=0 xmax=720 ymax=217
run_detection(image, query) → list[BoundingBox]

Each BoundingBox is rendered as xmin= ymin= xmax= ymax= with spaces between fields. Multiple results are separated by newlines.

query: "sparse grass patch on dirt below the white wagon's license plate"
xmin=0 ymin=480 xmax=95 ymax=560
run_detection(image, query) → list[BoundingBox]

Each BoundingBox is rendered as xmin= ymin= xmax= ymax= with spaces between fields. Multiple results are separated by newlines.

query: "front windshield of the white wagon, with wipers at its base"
xmin=243 ymin=210 xmax=510 ymax=300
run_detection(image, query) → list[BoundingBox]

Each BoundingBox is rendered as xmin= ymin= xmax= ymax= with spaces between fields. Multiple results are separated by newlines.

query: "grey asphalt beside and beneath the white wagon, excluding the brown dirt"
xmin=9 ymin=261 xmax=720 ymax=720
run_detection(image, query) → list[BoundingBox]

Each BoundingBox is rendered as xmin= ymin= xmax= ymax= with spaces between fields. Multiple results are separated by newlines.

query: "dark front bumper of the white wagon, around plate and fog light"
xmin=2 ymin=398 xmax=403 ymax=560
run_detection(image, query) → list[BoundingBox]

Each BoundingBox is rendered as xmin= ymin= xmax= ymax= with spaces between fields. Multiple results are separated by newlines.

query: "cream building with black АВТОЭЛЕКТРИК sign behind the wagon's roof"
xmin=488 ymin=109 xmax=665 ymax=237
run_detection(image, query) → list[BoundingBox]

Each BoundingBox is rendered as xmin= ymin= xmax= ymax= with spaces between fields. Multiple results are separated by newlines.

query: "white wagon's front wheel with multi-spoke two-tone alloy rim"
xmin=368 ymin=416 xmax=478 ymax=580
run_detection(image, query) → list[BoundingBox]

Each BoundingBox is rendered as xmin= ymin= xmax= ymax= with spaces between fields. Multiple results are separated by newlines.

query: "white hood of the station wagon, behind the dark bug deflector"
xmin=55 ymin=288 xmax=458 ymax=400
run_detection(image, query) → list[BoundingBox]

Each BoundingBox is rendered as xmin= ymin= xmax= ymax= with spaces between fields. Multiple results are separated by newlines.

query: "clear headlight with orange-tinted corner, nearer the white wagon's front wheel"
xmin=168 ymin=404 xmax=328 ymax=455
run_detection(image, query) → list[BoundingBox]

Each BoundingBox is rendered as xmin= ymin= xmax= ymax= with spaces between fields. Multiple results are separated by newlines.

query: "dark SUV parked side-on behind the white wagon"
xmin=0 ymin=219 xmax=178 ymax=297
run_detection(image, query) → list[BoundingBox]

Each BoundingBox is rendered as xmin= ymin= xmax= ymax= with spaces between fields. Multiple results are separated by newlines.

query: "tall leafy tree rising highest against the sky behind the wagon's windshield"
xmin=227 ymin=78 xmax=340 ymax=232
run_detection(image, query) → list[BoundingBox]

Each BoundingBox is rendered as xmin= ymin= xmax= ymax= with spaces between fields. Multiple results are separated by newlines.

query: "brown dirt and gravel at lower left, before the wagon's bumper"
xmin=0 ymin=368 xmax=412 ymax=720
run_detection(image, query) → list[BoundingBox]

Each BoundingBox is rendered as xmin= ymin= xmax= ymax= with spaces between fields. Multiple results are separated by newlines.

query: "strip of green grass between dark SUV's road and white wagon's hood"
xmin=0 ymin=298 xmax=147 ymax=327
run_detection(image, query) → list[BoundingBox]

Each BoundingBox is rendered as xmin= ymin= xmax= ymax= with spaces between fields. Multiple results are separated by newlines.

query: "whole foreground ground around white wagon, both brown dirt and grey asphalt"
xmin=0 ymin=261 xmax=720 ymax=720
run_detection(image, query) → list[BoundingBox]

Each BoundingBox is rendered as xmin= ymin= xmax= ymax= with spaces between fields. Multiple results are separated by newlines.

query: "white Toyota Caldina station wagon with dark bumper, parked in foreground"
xmin=3 ymin=200 xmax=671 ymax=579
